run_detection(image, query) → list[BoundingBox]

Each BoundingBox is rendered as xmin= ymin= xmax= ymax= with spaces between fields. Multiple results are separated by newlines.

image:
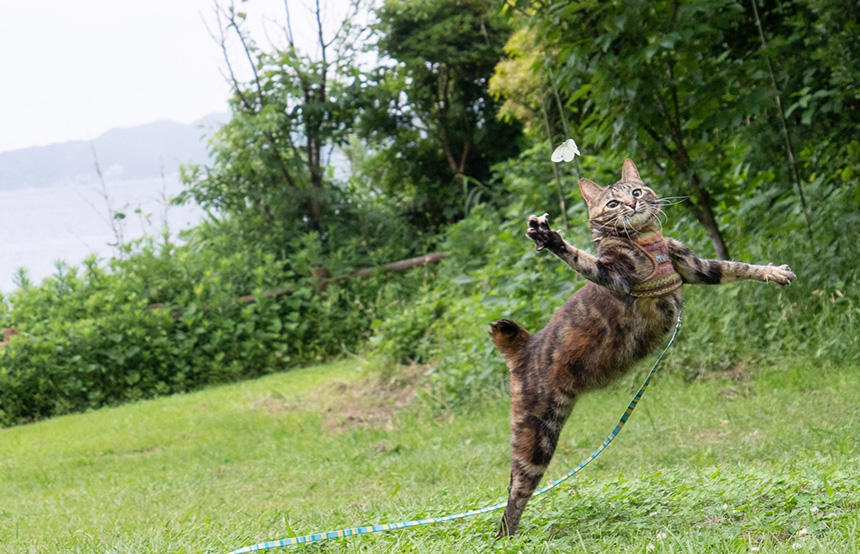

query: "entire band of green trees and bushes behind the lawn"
xmin=0 ymin=0 xmax=860 ymax=425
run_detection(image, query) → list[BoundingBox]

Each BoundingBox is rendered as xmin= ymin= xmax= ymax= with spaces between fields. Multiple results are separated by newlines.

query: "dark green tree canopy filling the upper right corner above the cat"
xmin=497 ymin=0 xmax=860 ymax=258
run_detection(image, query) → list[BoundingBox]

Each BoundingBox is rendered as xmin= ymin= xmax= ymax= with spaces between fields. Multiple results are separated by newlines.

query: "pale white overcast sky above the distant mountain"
xmin=0 ymin=0 xmax=347 ymax=151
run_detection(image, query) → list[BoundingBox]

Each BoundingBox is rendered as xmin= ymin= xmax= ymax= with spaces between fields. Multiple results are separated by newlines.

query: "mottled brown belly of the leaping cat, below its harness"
xmin=535 ymin=283 xmax=684 ymax=391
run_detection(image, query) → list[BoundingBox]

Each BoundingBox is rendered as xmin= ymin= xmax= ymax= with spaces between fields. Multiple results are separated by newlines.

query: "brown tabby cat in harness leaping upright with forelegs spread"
xmin=490 ymin=159 xmax=795 ymax=536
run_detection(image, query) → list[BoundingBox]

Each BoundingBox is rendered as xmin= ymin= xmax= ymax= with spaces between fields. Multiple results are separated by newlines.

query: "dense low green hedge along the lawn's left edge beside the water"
xmin=0 ymin=218 xmax=432 ymax=426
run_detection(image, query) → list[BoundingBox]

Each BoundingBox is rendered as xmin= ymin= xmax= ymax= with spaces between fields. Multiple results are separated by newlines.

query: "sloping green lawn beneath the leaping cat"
xmin=0 ymin=356 xmax=860 ymax=553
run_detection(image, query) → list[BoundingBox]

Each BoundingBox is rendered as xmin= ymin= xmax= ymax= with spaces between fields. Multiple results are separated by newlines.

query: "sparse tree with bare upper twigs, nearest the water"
xmin=183 ymin=0 xmax=362 ymax=238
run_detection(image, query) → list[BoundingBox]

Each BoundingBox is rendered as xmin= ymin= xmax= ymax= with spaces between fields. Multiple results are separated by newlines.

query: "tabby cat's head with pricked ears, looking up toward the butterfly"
xmin=579 ymin=159 xmax=661 ymax=237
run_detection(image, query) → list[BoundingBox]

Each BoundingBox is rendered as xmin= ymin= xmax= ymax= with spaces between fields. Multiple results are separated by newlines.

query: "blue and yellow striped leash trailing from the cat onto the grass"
xmin=230 ymin=314 xmax=681 ymax=554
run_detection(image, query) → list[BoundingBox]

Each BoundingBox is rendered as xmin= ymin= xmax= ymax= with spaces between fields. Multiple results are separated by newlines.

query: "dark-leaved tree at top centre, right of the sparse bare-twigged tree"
xmin=362 ymin=0 xmax=520 ymax=225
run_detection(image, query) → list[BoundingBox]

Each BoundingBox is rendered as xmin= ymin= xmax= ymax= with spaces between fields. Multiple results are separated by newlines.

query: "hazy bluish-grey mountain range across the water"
xmin=0 ymin=114 xmax=229 ymax=191
